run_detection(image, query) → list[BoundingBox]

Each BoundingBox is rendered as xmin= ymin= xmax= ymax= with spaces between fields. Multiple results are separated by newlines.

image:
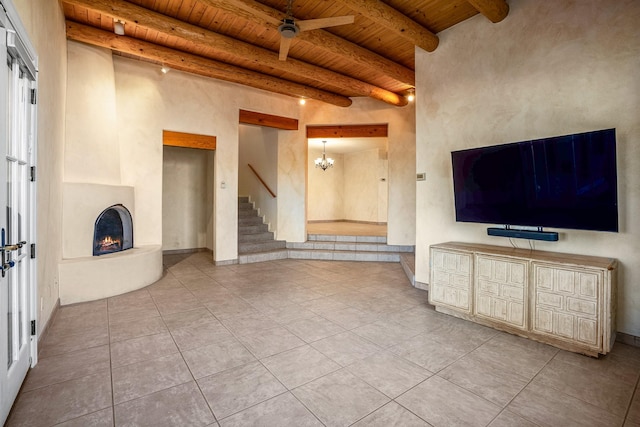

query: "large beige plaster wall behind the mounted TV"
xmin=416 ymin=0 xmax=640 ymax=336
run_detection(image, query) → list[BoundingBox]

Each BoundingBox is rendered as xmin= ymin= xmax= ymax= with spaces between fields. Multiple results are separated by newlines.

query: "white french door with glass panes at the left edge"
xmin=0 ymin=3 xmax=36 ymax=423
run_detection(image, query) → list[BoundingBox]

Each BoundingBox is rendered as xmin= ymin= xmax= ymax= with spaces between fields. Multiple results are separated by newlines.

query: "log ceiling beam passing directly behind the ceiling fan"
xmin=199 ymin=0 xmax=416 ymax=86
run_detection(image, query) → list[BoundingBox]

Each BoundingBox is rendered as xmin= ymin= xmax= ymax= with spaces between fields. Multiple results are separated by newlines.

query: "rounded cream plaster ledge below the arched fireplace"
xmin=59 ymin=245 xmax=162 ymax=305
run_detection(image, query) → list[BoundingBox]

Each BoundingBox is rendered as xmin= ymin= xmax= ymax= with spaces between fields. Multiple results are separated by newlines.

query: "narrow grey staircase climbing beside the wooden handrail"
xmin=238 ymin=197 xmax=287 ymax=264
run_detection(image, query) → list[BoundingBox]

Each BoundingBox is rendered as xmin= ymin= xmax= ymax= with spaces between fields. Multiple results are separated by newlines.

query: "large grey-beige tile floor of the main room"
xmin=8 ymin=254 xmax=640 ymax=427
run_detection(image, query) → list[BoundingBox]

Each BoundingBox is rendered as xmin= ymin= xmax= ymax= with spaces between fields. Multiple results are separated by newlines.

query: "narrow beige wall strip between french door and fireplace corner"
xmin=13 ymin=0 xmax=67 ymax=330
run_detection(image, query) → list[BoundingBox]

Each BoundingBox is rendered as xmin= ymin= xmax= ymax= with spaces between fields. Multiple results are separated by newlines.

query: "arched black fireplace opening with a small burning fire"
xmin=93 ymin=204 xmax=133 ymax=256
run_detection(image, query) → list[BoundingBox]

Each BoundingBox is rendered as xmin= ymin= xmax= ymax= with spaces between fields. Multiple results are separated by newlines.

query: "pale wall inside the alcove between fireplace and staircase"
xmin=162 ymin=147 xmax=214 ymax=251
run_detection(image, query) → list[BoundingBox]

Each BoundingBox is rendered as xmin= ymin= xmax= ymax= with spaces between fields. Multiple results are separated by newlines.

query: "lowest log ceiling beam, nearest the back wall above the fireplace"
xmin=67 ymin=21 xmax=351 ymax=107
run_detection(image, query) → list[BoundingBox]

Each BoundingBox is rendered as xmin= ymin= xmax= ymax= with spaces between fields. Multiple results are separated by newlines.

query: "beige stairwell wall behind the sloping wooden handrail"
xmin=238 ymin=125 xmax=281 ymax=234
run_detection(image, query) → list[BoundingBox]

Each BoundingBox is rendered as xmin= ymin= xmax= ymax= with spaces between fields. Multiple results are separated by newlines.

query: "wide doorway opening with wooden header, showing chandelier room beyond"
xmin=307 ymin=125 xmax=389 ymax=237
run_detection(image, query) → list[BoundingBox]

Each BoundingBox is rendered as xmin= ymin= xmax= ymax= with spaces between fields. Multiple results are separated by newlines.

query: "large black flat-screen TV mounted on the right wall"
xmin=451 ymin=129 xmax=618 ymax=231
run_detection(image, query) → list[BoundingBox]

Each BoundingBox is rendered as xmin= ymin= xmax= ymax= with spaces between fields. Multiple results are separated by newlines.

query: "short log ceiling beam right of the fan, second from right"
xmin=330 ymin=0 xmax=440 ymax=52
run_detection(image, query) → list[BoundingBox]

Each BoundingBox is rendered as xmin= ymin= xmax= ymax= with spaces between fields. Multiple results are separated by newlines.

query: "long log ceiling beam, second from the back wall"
xmin=65 ymin=0 xmax=408 ymax=106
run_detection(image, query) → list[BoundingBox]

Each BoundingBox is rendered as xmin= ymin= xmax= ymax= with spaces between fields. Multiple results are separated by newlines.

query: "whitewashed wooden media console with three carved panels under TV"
xmin=429 ymin=243 xmax=617 ymax=357
